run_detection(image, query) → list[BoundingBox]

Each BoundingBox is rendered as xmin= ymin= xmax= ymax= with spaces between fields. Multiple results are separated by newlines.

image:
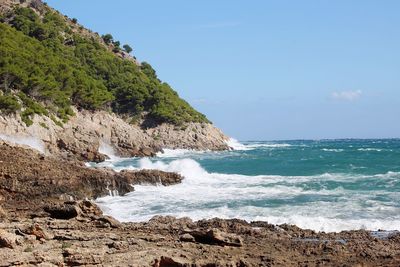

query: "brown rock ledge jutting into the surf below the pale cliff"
xmin=0 ymin=142 xmax=182 ymax=218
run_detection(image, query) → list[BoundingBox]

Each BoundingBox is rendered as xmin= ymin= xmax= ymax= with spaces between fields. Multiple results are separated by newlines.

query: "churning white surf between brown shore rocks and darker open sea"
xmin=97 ymin=158 xmax=400 ymax=232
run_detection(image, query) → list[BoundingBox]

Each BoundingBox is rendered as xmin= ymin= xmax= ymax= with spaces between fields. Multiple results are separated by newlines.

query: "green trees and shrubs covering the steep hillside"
xmin=0 ymin=4 xmax=208 ymax=125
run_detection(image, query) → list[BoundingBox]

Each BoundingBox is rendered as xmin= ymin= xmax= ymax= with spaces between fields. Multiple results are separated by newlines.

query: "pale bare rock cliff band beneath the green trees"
xmin=0 ymin=110 xmax=228 ymax=162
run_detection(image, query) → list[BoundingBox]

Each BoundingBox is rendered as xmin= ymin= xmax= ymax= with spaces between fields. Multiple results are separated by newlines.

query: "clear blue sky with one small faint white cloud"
xmin=47 ymin=0 xmax=400 ymax=140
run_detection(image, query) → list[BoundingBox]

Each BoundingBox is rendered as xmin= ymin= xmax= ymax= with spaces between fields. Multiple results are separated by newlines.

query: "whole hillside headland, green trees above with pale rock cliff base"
xmin=0 ymin=0 xmax=228 ymax=161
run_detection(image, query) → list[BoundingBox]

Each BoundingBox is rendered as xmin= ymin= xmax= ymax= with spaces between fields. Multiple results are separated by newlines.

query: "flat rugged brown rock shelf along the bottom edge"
xmin=0 ymin=205 xmax=400 ymax=267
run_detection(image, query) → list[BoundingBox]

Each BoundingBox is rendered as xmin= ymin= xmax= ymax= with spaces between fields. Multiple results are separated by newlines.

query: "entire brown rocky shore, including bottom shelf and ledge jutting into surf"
xmin=0 ymin=143 xmax=400 ymax=266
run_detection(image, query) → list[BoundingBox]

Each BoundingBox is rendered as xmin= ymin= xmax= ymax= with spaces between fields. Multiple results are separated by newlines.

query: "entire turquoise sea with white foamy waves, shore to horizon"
xmin=97 ymin=139 xmax=400 ymax=231
